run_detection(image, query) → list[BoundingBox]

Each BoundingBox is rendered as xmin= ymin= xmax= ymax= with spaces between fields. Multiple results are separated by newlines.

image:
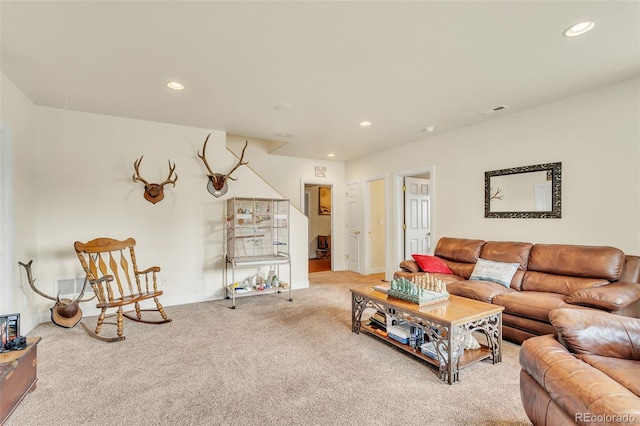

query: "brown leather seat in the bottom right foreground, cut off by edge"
xmin=520 ymin=308 xmax=640 ymax=426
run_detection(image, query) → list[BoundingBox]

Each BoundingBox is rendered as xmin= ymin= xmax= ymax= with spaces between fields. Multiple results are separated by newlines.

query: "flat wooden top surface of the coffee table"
xmin=350 ymin=285 xmax=504 ymax=326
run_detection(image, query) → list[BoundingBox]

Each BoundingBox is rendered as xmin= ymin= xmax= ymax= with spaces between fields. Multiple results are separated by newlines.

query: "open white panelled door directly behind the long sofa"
xmin=404 ymin=177 xmax=431 ymax=259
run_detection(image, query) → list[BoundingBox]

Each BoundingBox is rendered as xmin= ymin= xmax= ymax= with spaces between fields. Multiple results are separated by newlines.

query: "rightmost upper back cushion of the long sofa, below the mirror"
xmin=527 ymin=244 xmax=624 ymax=281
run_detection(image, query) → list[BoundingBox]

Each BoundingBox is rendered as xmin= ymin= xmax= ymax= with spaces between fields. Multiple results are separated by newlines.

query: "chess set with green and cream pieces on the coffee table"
xmin=387 ymin=274 xmax=449 ymax=306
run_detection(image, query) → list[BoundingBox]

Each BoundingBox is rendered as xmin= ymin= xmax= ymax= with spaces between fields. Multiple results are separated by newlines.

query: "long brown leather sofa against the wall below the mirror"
xmin=394 ymin=237 xmax=640 ymax=343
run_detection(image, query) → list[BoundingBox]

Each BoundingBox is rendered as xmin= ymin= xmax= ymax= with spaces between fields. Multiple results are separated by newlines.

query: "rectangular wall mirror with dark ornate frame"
xmin=484 ymin=163 xmax=562 ymax=218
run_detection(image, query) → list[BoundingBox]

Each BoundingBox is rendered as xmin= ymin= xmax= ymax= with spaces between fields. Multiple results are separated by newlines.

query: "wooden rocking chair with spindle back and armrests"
xmin=74 ymin=238 xmax=171 ymax=342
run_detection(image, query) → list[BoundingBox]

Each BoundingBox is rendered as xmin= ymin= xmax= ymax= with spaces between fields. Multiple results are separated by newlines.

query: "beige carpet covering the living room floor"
xmin=6 ymin=272 xmax=530 ymax=426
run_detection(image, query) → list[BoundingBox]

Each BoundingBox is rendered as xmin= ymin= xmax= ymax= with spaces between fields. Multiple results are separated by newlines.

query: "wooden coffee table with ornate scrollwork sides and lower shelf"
xmin=350 ymin=285 xmax=504 ymax=384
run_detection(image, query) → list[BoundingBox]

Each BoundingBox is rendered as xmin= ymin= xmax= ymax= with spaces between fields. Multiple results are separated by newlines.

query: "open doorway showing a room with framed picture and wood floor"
xmin=304 ymin=183 xmax=333 ymax=273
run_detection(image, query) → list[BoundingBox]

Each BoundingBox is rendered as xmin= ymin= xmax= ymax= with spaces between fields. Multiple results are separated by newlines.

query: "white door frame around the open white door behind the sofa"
xmin=387 ymin=164 xmax=438 ymax=279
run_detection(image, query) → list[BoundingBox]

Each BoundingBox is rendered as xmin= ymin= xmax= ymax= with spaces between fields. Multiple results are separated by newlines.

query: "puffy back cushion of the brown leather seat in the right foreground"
xmin=549 ymin=309 xmax=640 ymax=361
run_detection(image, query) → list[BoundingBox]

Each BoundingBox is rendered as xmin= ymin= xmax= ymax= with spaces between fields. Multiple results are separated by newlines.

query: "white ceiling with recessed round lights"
xmin=0 ymin=0 xmax=640 ymax=161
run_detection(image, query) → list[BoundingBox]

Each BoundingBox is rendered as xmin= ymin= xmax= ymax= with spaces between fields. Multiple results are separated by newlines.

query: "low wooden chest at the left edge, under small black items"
xmin=0 ymin=337 xmax=41 ymax=425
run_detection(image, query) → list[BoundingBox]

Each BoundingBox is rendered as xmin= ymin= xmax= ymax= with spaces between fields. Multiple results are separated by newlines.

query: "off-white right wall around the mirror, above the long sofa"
xmin=346 ymin=79 xmax=640 ymax=271
